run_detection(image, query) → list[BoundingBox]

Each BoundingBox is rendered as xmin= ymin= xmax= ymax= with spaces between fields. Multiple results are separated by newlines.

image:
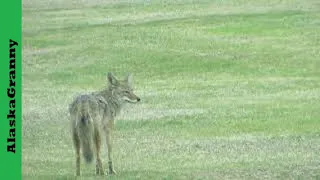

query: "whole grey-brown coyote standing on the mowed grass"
xmin=69 ymin=73 xmax=140 ymax=176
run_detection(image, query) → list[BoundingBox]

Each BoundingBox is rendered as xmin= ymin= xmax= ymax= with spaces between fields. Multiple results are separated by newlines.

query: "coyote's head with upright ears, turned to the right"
xmin=107 ymin=72 xmax=140 ymax=103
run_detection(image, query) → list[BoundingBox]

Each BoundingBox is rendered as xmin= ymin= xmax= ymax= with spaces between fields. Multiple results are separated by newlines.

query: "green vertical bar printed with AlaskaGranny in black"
xmin=0 ymin=0 xmax=22 ymax=180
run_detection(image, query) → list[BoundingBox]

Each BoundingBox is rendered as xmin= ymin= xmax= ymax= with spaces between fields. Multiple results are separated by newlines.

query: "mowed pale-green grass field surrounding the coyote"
xmin=22 ymin=0 xmax=320 ymax=180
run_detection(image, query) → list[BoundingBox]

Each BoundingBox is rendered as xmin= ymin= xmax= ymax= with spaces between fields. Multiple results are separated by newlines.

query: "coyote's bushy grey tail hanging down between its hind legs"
xmin=78 ymin=115 xmax=94 ymax=163
